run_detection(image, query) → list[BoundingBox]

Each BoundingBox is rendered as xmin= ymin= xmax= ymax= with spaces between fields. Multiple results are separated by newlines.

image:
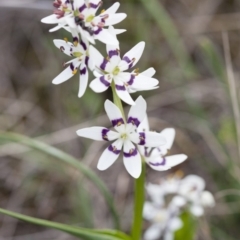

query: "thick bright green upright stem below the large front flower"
xmin=131 ymin=159 xmax=146 ymax=240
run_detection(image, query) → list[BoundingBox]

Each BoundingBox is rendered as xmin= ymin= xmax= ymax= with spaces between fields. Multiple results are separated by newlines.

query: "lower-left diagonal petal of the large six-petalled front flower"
xmin=97 ymin=139 xmax=123 ymax=170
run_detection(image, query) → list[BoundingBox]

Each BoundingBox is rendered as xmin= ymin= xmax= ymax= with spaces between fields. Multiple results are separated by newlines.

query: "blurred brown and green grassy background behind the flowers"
xmin=0 ymin=0 xmax=240 ymax=240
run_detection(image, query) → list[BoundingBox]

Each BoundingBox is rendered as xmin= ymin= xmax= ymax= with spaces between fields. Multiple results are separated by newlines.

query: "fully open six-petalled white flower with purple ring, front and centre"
xmin=77 ymin=96 xmax=165 ymax=178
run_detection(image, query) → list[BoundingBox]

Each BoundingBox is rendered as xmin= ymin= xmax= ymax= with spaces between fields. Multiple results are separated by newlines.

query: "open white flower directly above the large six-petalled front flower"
xmin=89 ymin=39 xmax=158 ymax=105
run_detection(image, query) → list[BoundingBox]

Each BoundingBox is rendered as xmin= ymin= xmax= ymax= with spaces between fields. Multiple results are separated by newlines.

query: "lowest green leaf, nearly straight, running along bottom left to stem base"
xmin=0 ymin=208 xmax=131 ymax=240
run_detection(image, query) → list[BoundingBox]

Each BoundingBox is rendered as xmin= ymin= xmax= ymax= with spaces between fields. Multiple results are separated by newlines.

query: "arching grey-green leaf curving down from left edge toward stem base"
xmin=0 ymin=132 xmax=119 ymax=229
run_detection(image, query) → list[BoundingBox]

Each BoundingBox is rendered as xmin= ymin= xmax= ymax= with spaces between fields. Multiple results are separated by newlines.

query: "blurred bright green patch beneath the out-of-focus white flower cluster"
xmin=174 ymin=212 xmax=197 ymax=240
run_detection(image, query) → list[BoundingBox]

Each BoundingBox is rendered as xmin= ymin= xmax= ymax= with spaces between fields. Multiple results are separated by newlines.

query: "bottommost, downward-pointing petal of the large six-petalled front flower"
xmin=123 ymin=140 xmax=142 ymax=178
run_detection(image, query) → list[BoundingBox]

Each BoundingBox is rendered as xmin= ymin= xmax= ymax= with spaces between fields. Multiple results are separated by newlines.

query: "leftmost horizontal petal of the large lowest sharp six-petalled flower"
xmin=77 ymin=127 xmax=119 ymax=141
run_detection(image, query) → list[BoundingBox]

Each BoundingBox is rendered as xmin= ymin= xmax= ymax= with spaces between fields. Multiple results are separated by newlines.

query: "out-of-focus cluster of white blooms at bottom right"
xmin=143 ymin=175 xmax=215 ymax=240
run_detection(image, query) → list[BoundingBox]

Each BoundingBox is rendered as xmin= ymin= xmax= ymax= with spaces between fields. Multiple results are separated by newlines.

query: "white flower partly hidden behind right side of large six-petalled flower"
xmin=138 ymin=116 xmax=187 ymax=171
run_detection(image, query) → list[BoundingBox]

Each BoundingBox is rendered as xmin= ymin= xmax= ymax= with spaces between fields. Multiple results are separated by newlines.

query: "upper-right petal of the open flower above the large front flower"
xmin=118 ymin=42 xmax=145 ymax=71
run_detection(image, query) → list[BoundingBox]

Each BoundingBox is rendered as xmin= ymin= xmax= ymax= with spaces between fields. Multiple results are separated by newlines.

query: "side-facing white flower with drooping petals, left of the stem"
xmin=52 ymin=30 xmax=93 ymax=97
